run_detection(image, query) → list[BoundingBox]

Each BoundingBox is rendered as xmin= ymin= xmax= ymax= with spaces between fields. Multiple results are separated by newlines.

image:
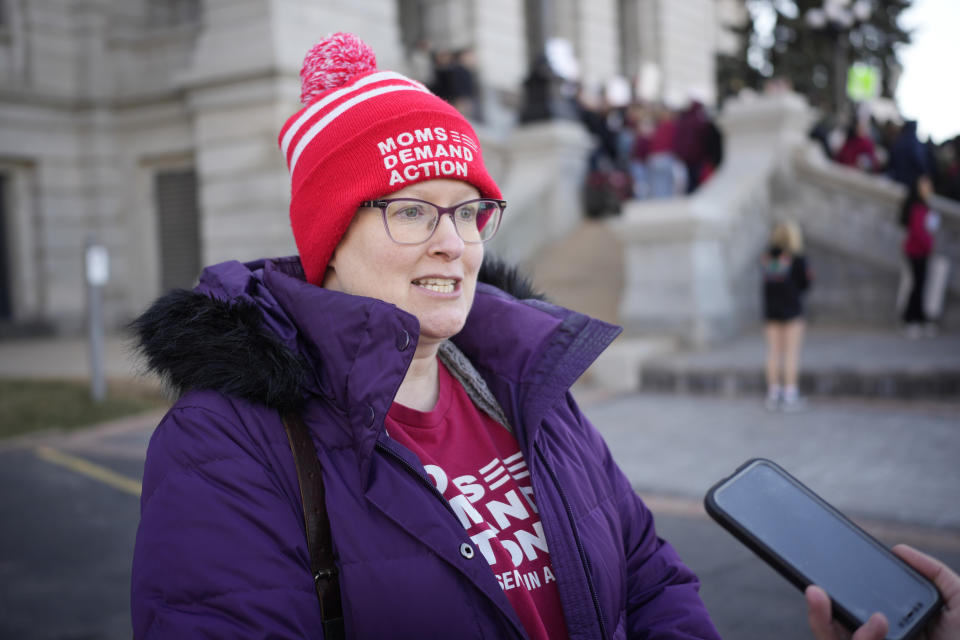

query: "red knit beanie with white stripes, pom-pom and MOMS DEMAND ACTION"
xmin=280 ymin=33 xmax=502 ymax=285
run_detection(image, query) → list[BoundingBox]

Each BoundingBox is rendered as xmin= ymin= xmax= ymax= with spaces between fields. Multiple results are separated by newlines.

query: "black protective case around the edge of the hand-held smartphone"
xmin=703 ymin=458 xmax=942 ymax=640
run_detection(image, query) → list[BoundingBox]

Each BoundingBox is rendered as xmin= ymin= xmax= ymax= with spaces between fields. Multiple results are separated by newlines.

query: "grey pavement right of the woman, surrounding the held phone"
xmin=586 ymin=394 xmax=960 ymax=640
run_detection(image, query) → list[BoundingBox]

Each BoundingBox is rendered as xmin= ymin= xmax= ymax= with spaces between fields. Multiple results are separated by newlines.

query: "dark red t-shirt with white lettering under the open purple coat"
xmin=386 ymin=364 xmax=568 ymax=640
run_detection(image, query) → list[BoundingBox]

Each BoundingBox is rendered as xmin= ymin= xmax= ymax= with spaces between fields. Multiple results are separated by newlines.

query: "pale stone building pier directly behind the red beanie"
xmin=183 ymin=0 xmax=410 ymax=264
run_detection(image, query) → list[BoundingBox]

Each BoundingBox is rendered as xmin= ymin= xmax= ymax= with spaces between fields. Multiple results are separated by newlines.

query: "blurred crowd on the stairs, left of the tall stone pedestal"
xmin=577 ymin=91 xmax=723 ymax=216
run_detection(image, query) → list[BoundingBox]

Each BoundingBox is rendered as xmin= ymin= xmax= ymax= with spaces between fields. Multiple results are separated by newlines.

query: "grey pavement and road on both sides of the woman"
xmin=0 ymin=334 xmax=960 ymax=640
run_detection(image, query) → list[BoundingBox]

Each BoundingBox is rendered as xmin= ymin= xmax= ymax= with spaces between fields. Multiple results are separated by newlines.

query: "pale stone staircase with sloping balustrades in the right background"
xmin=524 ymin=94 xmax=960 ymax=399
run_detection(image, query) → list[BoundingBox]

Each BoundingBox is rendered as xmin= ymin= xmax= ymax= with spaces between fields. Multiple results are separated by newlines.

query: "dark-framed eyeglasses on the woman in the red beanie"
xmin=360 ymin=198 xmax=507 ymax=244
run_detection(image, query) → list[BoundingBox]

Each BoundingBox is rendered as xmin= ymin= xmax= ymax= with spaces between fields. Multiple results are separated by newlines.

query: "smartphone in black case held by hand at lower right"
xmin=704 ymin=458 xmax=942 ymax=640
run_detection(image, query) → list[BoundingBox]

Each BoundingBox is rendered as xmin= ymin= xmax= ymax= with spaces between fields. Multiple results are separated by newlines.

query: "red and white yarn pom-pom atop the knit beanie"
xmin=300 ymin=32 xmax=377 ymax=107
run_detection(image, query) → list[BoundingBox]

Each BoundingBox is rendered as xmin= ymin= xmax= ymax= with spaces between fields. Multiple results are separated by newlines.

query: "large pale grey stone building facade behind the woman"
xmin=0 ymin=0 xmax=717 ymax=335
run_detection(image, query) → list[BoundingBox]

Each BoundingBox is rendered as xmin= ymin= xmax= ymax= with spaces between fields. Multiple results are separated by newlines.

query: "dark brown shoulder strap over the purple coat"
xmin=283 ymin=412 xmax=344 ymax=640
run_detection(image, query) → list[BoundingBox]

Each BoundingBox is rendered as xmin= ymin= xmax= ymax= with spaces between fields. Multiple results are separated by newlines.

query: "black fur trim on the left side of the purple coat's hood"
xmin=130 ymin=289 xmax=308 ymax=411
